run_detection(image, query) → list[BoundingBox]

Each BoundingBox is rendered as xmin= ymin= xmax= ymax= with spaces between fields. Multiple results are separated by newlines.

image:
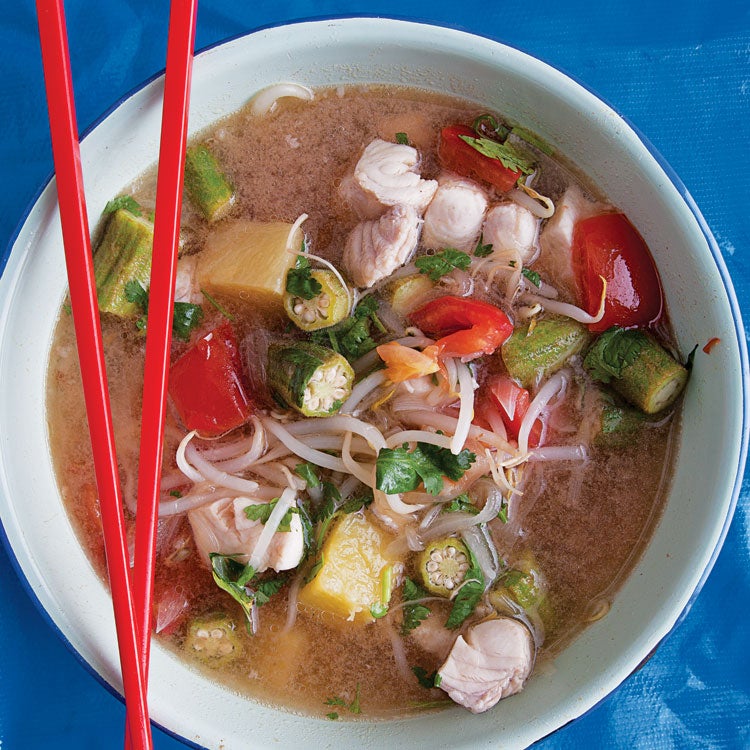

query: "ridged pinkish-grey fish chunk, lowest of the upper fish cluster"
xmin=343 ymin=205 xmax=422 ymax=287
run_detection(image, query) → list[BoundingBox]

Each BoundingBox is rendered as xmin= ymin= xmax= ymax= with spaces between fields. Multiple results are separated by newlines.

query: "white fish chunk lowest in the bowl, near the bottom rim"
xmin=438 ymin=617 xmax=534 ymax=714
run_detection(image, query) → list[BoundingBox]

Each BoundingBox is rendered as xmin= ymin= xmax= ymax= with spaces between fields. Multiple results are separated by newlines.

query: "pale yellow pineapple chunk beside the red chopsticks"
xmin=196 ymin=220 xmax=302 ymax=311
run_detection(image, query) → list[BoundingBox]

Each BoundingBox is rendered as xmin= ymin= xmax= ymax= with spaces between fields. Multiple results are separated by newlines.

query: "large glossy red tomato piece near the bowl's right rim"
xmin=573 ymin=213 xmax=664 ymax=331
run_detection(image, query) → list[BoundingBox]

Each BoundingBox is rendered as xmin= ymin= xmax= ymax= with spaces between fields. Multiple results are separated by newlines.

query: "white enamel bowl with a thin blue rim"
xmin=0 ymin=18 xmax=747 ymax=749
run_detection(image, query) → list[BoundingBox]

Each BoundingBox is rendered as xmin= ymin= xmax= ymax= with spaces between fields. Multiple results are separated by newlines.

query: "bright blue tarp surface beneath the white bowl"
xmin=0 ymin=0 xmax=750 ymax=750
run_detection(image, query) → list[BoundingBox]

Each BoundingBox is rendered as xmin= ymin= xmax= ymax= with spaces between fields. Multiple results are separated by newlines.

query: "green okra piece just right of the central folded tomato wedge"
xmin=502 ymin=317 xmax=590 ymax=390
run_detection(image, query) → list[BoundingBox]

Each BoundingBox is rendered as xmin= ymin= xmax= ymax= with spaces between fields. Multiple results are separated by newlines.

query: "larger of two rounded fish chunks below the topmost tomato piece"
xmin=422 ymin=178 xmax=487 ymax=253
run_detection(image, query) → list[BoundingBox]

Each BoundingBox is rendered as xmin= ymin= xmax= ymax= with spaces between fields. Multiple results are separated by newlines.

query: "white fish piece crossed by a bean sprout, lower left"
xmin=188 ymin=497 xmax=305 ymax=572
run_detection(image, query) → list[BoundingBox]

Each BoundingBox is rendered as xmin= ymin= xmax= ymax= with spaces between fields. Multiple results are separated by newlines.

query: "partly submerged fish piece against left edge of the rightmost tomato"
xmin=539 ymin=185 xmax=612 ymax=299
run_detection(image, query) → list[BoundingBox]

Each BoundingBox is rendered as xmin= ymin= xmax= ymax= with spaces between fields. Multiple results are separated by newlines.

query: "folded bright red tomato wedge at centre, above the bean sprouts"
xmin=409 ymin=296 xmax=513 ymax=361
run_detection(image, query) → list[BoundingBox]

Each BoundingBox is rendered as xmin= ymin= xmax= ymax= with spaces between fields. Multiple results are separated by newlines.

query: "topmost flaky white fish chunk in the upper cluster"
xmin=340 ymin=138 xmax=438 ymax=219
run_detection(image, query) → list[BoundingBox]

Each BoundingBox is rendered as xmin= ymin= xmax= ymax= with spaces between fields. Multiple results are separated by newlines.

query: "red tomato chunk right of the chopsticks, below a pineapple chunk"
xmin=169 ymin=322 xmax=252 ymax=436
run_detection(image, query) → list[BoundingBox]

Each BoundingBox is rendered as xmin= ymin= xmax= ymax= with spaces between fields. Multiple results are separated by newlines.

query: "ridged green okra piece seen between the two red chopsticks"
xmin=94 ymin=208 xmax=154 ymax=318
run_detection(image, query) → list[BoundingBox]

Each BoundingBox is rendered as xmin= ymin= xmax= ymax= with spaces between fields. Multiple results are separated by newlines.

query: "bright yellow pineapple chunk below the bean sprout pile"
xmin=299 ymin=513 xmax=393 ymax=623
